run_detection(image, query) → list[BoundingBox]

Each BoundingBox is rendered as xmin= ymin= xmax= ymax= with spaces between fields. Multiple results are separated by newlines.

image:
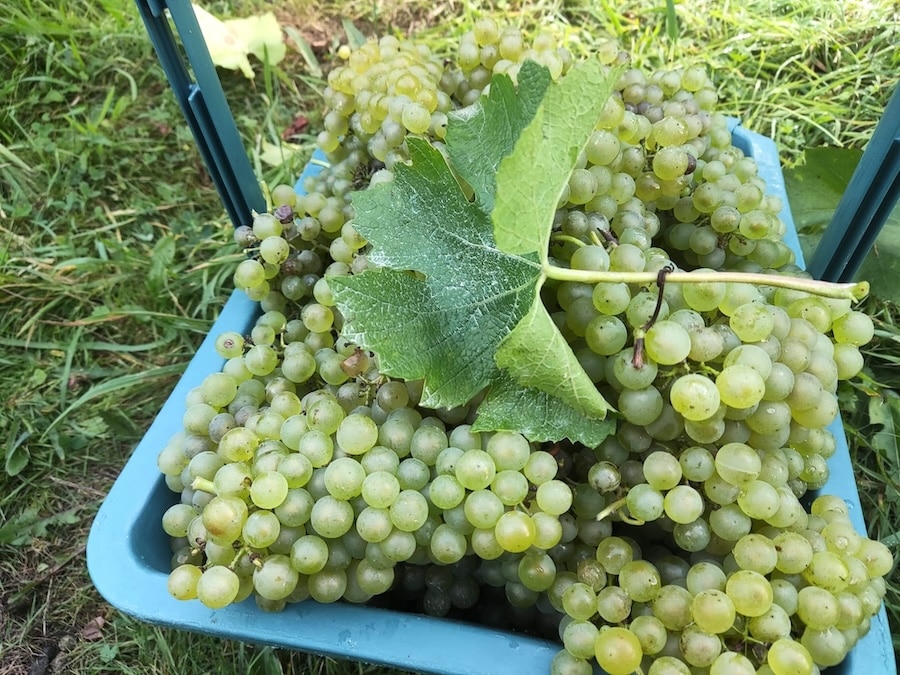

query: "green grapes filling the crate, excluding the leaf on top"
xmin=158 ymin=19 xmax=893 ymax=675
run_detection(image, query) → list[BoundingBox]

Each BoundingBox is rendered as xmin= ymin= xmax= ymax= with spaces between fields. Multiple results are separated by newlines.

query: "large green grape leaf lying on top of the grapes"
xmin=329 ymin=61 xmax=615 ymax=445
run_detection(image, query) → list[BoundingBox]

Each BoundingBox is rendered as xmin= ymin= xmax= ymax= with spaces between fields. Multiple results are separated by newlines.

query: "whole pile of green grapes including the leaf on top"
xmin=153 ymin=20 xmax=892 ymax=675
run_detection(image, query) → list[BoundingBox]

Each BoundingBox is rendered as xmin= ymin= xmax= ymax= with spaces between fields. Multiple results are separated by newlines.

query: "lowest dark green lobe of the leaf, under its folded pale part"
xmin=472 ymin=371 xmax=616 ymax=448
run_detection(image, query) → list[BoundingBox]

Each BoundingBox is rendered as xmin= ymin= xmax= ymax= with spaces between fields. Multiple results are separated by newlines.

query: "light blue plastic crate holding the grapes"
xmin=87 ymin=0 xmax=896 ymax=675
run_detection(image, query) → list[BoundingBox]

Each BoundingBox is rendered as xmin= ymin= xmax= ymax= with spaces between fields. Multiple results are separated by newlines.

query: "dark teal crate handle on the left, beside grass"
xmin=135 ymin=0 xmax=266 ymax=227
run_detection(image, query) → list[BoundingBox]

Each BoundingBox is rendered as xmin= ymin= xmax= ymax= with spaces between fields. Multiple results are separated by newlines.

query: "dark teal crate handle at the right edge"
xmin=809 ymin=86 xmax=900 ymax=281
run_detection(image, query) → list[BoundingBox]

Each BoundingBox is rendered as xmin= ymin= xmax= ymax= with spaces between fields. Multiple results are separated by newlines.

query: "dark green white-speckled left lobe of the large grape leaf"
xmin=329 ymin=139 xmax=541 ymax=408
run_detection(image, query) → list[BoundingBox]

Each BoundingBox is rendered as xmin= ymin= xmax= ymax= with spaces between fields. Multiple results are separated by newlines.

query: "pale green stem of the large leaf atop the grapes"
xmin=542 ymin=262 xmax=869 ymax=301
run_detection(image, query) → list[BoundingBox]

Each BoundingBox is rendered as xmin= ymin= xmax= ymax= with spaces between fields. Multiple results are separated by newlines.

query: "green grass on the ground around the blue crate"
xmin=0 ymin=0 xmax=900 ymax=675
